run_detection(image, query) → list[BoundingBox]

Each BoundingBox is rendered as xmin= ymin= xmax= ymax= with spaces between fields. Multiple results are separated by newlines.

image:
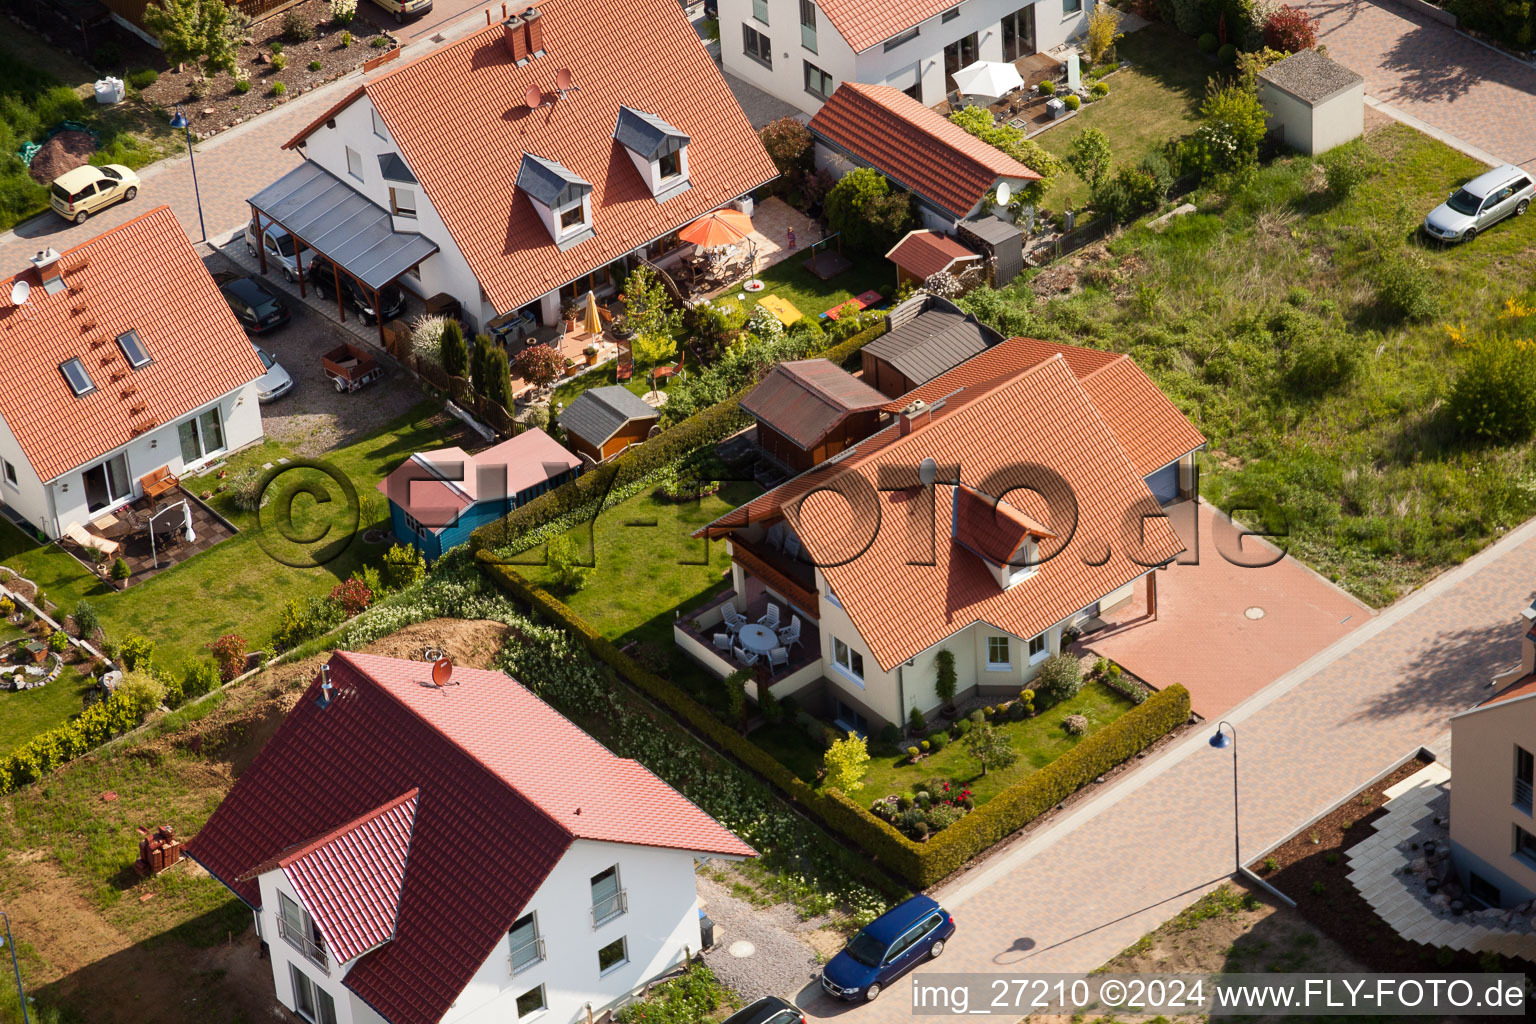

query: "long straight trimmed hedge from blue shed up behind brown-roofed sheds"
xmin=470 ymin=321 xmax=885 ymax=551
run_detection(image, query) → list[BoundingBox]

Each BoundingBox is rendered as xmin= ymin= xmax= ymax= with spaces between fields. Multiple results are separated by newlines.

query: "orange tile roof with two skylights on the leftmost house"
xmin=0 ymin=206 xmax=266 ymax=481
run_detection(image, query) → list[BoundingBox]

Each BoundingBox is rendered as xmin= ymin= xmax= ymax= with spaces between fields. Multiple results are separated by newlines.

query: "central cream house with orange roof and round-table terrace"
xmin=674 ymin=338 xmax=1206 ymax=732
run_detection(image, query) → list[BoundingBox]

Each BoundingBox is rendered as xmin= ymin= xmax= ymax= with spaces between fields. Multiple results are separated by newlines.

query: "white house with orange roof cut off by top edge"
xmin=720 ymin=0 xmax=1092 ymax=114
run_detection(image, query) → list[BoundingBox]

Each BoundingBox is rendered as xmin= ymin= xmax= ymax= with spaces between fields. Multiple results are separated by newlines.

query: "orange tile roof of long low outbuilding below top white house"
xmin=809 ymin=81 xmax=1040 ymax=218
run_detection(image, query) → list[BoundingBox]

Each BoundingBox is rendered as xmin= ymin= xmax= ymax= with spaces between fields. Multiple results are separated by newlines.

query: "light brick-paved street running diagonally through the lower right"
xmin=800 ymin=520 xmax=1536 ymax=1024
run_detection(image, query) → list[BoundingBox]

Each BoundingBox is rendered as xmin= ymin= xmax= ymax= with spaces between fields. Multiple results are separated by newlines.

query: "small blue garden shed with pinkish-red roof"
xmin=378 ymin=427 xmax=581 ymax=559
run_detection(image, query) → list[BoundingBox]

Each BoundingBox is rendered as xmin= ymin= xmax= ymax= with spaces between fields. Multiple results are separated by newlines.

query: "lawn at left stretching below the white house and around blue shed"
xmin=0 ymin=402 xmax=458 ymax=671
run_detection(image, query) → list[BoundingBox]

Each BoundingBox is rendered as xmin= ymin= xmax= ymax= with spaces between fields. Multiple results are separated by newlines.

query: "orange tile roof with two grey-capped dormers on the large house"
xmin=287 ymin=0 xmax=777 ymax=312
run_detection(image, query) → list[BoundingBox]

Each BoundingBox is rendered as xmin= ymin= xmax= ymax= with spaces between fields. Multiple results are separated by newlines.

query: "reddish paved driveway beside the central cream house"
xmin=1083 ymin=502 xmax=1375 ymax=718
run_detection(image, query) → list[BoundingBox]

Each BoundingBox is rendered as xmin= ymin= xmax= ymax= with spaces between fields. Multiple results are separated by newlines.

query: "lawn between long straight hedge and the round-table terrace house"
xmin=513 ymin=482 xmax=762 ymax=660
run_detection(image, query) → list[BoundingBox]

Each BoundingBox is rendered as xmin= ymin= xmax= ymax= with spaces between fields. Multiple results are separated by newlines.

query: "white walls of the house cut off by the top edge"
xmin=720 ymin=0 xmax=1092 ymax=114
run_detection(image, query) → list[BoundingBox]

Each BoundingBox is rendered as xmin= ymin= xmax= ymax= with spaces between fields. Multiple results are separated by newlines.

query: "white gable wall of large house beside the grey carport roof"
xmin=293 ymin=95 xmax=491 ymax=327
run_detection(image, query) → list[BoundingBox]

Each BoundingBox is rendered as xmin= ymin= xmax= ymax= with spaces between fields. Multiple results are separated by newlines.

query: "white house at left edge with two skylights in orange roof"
xmin=0 ymin=206 xmax=266 ymax=537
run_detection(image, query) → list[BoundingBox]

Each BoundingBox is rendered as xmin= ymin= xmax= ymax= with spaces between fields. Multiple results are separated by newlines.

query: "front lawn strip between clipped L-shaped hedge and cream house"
xmin=750 ymin=683 xmax=1132 ymax=804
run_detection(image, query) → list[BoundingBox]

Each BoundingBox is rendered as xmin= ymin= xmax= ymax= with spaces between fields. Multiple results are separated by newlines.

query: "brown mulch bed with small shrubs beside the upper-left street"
xmin=143 ymin=0 xmax=399 ymax=138
